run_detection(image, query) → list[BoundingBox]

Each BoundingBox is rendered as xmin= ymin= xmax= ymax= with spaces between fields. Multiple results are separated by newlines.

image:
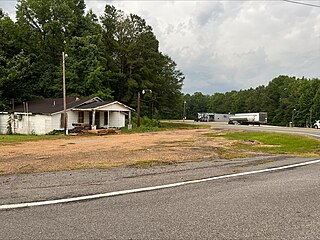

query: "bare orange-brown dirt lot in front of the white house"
xmin=0 ymin=129 xmax=244 ymax=174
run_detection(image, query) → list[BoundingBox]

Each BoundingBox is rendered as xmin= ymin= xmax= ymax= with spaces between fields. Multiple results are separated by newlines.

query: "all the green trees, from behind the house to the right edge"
xmin=0 ymin=0 xmax=320 ymax=126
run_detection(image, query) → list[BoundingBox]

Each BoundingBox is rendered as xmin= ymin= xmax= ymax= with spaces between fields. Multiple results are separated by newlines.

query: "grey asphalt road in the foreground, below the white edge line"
xmin=0 ymin=160 xmax=320 ymax=239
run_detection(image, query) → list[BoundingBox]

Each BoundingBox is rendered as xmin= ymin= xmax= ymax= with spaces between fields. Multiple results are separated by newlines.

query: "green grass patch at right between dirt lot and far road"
xmin=224 ymin=132 xmax=320 ymax=156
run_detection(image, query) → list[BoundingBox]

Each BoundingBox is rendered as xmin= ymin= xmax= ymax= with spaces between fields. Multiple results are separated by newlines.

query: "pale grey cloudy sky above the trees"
xmin=0 ymin=0 xmax=320 ymax=94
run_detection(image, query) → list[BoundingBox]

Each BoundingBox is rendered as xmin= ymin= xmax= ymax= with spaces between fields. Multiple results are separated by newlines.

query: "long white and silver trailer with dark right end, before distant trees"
xmin=229 ymin=112 xmax=267 ymax=126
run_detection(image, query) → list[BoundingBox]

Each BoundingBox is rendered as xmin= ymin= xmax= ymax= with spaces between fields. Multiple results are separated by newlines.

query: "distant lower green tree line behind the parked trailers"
xmin=183 ymin=76 xmax=320 ymax=127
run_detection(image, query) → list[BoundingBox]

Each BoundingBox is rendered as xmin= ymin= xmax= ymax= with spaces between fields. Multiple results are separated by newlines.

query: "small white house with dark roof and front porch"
xmin=0 ymin=97 xmax=134 ymax=135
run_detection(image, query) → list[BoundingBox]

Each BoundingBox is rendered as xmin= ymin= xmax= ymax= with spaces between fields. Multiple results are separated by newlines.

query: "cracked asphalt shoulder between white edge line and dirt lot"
xmin=0 ymin=155 xmax=312 ymax=205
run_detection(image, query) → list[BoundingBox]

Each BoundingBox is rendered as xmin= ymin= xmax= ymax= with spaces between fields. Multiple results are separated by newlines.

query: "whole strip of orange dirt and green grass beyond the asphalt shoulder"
xmin=0 ymin=129 xmax=312 ymax=174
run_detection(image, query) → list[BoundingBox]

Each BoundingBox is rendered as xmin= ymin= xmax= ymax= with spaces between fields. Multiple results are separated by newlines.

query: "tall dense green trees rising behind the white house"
xmin=0 ymin=0 xmax=184 ymax=118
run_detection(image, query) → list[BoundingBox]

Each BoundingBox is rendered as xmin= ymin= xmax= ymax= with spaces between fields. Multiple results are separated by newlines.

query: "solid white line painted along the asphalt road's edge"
xmin=0 ymin=159 xmax=320 ymax=210
